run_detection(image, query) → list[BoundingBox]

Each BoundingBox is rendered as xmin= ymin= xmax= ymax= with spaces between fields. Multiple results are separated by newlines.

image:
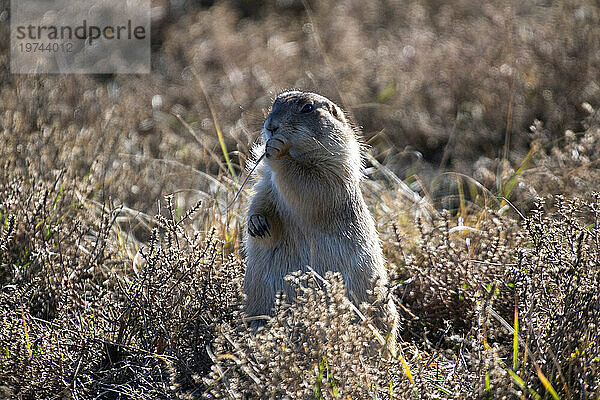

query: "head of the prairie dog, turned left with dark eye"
xmin=262 ymin=91 xmax=360 ymax=161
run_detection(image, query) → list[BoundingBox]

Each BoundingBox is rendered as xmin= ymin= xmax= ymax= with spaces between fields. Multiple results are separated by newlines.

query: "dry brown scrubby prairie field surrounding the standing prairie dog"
xmin=0 ymin=0 xmax=600 ymax=400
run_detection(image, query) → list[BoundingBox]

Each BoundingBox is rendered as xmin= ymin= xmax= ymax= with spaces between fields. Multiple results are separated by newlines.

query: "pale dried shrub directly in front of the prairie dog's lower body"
xmin=207 ymin=272 xmax=408 ymax=399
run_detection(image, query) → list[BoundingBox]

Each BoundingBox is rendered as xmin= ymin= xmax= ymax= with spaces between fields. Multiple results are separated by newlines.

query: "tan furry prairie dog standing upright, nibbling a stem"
xmin=244 ymin=91 xmax=397 ymax=348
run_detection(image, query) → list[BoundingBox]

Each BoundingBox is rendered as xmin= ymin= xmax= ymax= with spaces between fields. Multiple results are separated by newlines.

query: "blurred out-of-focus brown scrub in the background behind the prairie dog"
xmin=0 ymin=0 xmax=600 ymax=239
